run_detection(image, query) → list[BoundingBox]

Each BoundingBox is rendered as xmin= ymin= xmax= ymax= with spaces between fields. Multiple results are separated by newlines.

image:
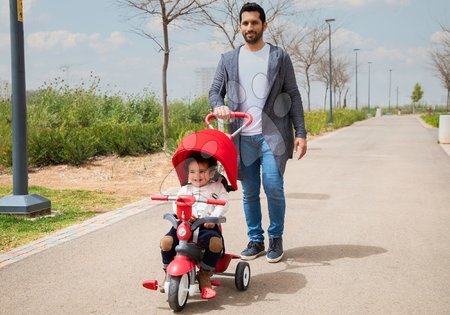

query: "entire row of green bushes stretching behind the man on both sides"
xmin=0 ymin=74 xmax=372 ymax=166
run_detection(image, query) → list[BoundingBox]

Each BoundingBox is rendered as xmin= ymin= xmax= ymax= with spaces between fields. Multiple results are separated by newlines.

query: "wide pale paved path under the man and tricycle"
xmin=0 ymin=116 xmax=450 ymax=315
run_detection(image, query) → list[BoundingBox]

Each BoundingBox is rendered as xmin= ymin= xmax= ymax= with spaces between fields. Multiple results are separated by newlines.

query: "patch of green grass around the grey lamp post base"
xmin=0 ymin=186 xmax=128 ymax=252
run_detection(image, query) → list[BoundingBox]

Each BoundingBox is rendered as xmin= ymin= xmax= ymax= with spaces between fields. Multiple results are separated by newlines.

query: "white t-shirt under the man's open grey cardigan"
xmin=239 ymin=44 xmax=270 ymax=136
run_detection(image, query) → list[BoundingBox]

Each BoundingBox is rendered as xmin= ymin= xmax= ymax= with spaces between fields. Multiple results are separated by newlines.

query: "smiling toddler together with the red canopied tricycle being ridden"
xmin=143 ymin=113 xmax=252 ymax=311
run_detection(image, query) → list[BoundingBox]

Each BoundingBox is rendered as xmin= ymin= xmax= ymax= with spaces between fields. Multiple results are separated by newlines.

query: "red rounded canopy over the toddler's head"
xmin=172 ymin=129 xmax=237 ymax=190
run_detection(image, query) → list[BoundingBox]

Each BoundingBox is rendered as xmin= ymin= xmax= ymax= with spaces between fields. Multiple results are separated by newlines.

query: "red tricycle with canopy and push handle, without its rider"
xmin=142 ymin=112 xmax=253 ymax=312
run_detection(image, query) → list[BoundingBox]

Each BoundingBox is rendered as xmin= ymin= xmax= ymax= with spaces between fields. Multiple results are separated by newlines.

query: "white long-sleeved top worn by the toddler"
xmin=173 ymin=181 xmax=228 ymax=218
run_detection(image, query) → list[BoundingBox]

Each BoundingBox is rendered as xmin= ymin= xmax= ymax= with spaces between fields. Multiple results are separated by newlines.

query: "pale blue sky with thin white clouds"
xmin=0 ymin=0 xmax=450 ymax=108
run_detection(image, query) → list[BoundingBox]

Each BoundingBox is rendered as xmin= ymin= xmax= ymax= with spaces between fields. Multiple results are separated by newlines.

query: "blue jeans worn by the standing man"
xmin=239 ymin=135 xmax=286 ymax=242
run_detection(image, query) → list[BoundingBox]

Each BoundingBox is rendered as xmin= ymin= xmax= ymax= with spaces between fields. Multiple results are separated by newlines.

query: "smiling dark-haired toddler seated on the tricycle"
xmin=160 ymin=153 xmax=228 ymax=299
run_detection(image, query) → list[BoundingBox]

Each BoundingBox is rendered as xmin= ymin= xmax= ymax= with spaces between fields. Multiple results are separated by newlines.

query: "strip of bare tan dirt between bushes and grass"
xmin=0 ymin=153 xmax=179 ymax=201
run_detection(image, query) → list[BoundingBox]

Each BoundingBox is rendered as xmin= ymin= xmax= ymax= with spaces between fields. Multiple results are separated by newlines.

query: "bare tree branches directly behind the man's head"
xmin=202 ymin=0 xmax=294 ymax=49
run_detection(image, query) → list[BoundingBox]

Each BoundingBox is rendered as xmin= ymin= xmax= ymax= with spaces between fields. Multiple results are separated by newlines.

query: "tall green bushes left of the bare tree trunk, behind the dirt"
xmin=0 ymin=76 xmax=169 ymax=166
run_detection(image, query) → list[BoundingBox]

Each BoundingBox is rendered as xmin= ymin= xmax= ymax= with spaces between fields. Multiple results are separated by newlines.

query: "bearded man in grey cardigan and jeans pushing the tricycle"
xmin=209 ymin=3 xmax=307 ymax=262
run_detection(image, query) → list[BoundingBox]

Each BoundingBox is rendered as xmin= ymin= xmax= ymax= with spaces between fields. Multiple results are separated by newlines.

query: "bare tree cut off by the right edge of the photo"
xmin=431 ymin=26 xmax=450 ymax=112
